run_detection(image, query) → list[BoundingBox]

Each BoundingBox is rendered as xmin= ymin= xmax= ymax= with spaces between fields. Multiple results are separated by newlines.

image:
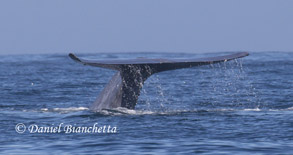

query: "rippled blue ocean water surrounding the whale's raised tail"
xmin=0 ymin=52 xmax=293 ymax=154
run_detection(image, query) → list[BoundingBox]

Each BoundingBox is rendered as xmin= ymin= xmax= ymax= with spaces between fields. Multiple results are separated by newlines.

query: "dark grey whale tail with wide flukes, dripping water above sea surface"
xmin=69 ymin=52 xmax=249 ymax=111
